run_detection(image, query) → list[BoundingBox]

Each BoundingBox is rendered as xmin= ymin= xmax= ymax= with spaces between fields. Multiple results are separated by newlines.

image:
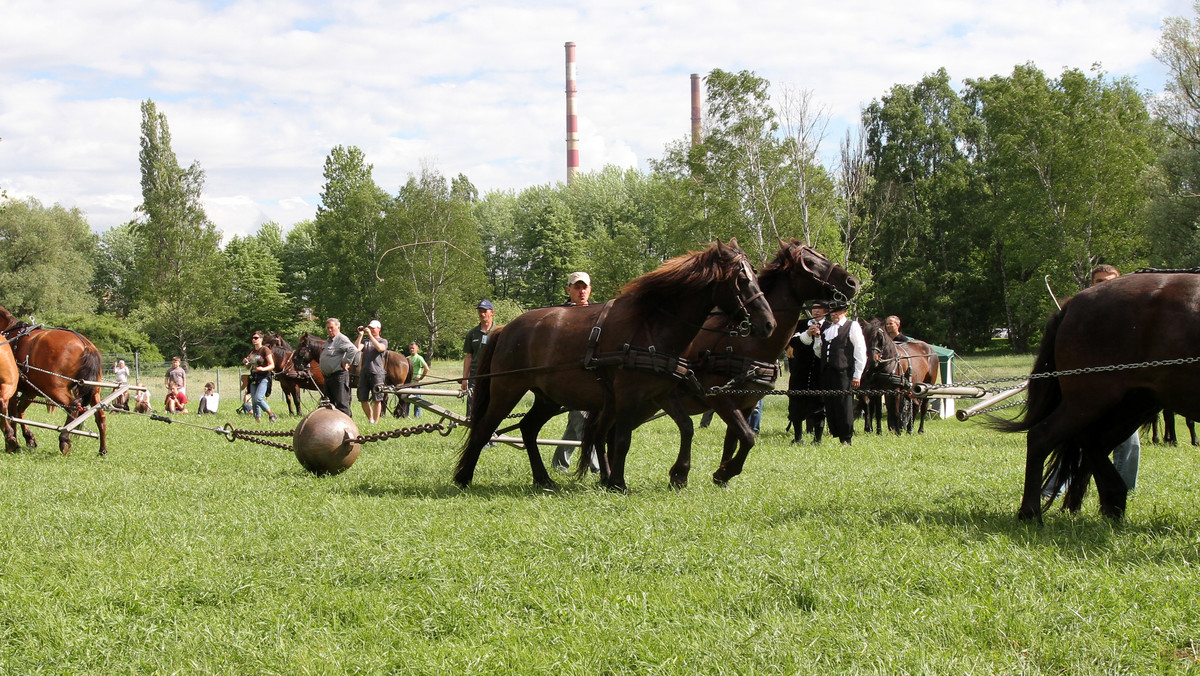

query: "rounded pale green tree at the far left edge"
xmin=0 ymin=198 xmax=96 ymax=315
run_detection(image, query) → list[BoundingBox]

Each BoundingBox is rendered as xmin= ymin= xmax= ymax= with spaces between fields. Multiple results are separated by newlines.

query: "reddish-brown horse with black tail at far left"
xmin=0 ymin=307 xmax=108 ymax=455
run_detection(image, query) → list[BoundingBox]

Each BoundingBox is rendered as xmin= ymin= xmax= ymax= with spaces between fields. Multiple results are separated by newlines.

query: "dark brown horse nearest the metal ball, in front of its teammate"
xmin=454 ymin=240 xmax=775 ymax=492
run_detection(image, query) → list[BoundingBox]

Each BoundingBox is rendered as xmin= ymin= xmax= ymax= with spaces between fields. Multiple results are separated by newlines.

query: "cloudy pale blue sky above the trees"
xmin=0 ymin=0 xmax=1193 ymax=238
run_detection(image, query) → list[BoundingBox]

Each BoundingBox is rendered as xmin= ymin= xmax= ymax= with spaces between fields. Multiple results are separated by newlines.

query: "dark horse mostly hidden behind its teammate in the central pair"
xmin=643 ymin=239 xmax=858 ymax=487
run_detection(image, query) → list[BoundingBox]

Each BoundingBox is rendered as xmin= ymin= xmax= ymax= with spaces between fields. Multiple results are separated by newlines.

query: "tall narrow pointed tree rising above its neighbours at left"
xmin=133 ymin=100 xmax=229 ymax=363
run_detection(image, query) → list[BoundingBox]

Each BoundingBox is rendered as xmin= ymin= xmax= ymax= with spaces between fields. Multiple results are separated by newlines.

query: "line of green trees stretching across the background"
xmin=7 ymin=10 xmax=1200 ymax=365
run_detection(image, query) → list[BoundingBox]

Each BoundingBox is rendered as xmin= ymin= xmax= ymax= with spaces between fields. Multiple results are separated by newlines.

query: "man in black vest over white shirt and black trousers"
xmin=808 ymin=303 xmax=866 ymax=444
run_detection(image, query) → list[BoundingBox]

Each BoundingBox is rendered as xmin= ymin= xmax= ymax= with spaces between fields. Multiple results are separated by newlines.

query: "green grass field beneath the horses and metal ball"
xmin=0 ymin=357 xmax=1200 ymax=674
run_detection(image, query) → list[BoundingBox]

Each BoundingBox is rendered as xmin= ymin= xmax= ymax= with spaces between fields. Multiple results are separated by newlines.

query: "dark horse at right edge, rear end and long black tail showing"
xmin=991 ymin=273 xmax=1200 ymax=522
